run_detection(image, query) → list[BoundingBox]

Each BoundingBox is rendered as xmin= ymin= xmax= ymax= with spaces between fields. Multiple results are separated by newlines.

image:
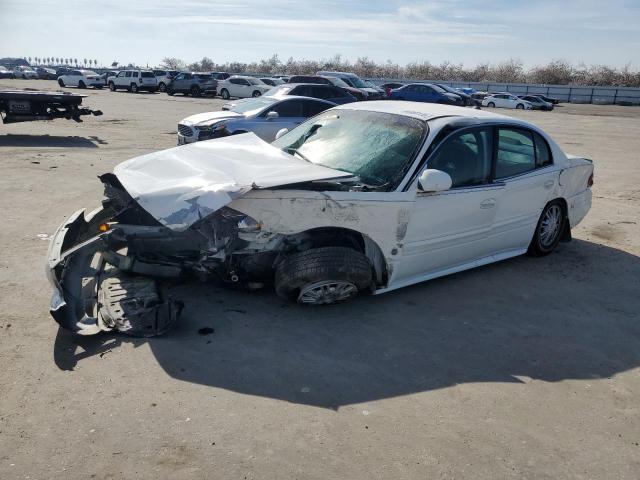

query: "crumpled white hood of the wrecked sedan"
xmin=113 ymin=133 xmax=353 ymax=230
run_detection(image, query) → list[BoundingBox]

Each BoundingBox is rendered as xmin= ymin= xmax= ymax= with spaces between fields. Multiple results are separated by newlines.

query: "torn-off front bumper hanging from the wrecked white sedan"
xmin=48 ymin=210 xmax=183 ymax=337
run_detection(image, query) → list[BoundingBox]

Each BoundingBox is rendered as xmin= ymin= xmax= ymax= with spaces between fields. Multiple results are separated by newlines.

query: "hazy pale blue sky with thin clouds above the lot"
xmin=0 ymin=0 xmax=640 ymax=68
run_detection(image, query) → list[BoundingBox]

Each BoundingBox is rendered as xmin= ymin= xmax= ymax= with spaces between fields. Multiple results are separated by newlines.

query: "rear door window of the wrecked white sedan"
xmin=496 ymin=128 xmax=536 ymax=179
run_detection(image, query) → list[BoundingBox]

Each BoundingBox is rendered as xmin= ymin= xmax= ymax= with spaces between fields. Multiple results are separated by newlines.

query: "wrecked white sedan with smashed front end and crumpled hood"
xmin=48 ymin=101 xmax=593 ymax=335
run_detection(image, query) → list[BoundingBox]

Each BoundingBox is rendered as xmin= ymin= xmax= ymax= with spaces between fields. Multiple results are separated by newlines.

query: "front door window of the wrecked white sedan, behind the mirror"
xmin=427 ymin=128 xmax=493 ymax=188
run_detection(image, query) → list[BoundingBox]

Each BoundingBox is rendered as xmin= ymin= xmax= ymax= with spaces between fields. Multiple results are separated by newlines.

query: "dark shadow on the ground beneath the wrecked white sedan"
xmin=55 ymin=241 xmax=640 ymax=409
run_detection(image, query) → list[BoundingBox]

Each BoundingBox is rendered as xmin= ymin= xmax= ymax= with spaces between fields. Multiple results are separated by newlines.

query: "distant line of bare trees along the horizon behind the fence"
xmin=163 ymin=55 xmax=640 ymax=87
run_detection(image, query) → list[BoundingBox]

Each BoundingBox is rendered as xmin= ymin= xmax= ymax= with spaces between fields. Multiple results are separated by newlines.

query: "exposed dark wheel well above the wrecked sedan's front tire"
xmin=288 ymin=227 xmax=388 ymax=286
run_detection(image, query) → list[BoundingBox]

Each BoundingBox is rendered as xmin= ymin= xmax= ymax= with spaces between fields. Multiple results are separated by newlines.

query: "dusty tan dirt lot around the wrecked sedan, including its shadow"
xmin=0 ymin=80 xmax=640 ymax=480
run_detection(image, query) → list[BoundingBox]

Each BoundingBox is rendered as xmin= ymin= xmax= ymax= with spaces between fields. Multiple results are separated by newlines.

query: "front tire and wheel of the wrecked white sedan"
xmin=275 ymin=247 xmax=373 ymax=305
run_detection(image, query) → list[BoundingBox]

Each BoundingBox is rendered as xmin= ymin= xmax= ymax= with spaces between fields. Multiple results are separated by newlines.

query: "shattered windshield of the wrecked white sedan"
xmin=273 ymin=109 xmax=427 ymax=191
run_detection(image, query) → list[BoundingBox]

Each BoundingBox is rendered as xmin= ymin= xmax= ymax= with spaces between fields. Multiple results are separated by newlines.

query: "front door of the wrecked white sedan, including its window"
xmin=392 ymin=127 xmax=504 ymax=284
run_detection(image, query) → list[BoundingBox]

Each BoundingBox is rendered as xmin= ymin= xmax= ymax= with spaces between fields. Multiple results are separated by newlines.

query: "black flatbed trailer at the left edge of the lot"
xmin=0 ymin=90 xmax=102 ymax=123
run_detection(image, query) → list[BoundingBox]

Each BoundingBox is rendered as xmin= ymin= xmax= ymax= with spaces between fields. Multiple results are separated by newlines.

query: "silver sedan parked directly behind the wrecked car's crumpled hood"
xmin=178 ymin=96 xmax=335 ymax=145
